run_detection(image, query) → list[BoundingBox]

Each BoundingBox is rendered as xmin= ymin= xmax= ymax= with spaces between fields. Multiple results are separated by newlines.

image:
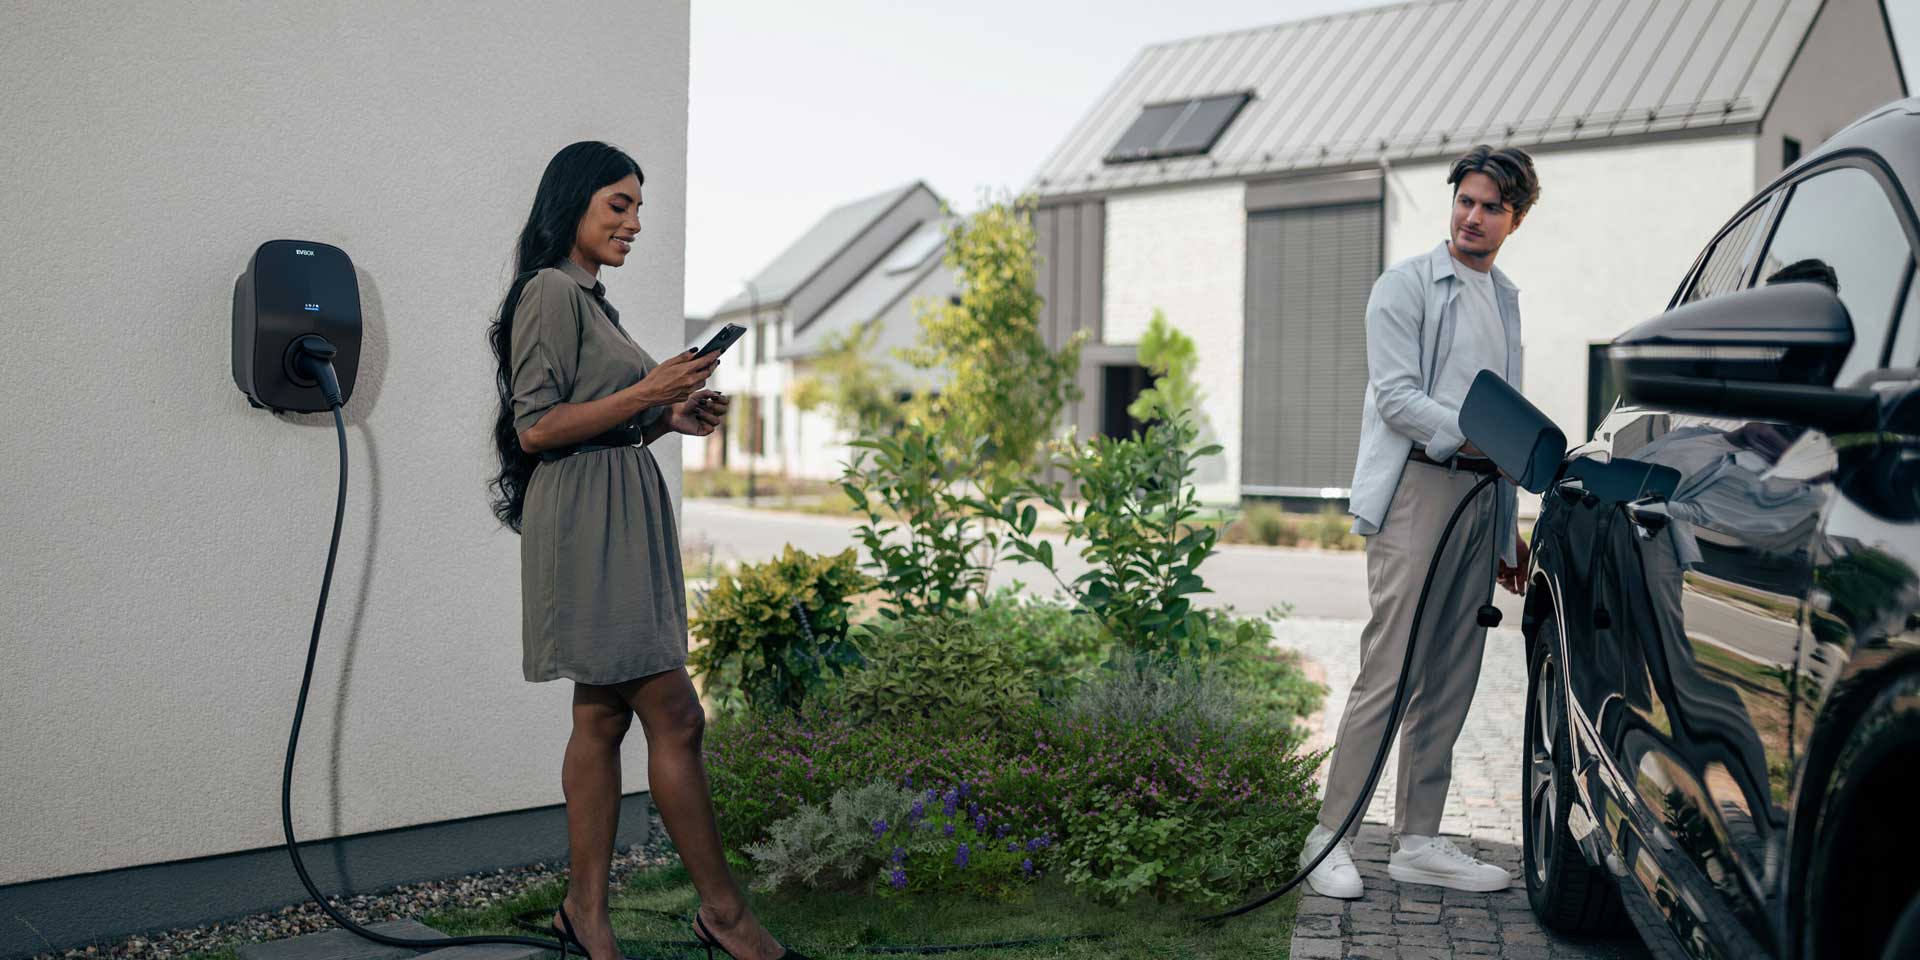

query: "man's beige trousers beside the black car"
xmin=1319 ymin=461 xmax=1498 ymax=837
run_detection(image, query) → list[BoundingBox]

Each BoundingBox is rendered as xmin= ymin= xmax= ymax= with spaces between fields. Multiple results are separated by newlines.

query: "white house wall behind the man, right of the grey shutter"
xmin=1386 ymin=134 xmax=1755 ymax=444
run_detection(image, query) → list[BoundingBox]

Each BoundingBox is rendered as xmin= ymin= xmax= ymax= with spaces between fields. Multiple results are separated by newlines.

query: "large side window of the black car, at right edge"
xmin=1759 ymin=167 xmax=1912 ymax=386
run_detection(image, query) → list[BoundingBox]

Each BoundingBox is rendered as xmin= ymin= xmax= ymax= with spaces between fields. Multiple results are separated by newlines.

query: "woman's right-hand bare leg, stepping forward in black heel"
xmin=620 ymin=668 xmax=783 ymax=960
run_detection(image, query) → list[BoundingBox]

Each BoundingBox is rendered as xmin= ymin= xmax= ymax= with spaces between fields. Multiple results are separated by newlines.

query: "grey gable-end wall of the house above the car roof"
xmin=1753 ymin=0 xmax=1907 ymax=190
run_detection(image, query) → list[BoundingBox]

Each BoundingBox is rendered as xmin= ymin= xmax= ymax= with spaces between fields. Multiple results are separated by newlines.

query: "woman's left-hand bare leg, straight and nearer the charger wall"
xmin=553 ymin=684 xmax=634 ymax=960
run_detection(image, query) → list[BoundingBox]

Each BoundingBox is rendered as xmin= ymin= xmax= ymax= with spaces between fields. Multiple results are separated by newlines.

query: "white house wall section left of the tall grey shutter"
xmin=1100 ymin=182 xmax=1246 ymax=501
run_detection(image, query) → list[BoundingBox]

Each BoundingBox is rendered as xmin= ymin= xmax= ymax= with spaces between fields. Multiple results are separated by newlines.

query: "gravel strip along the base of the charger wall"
xmin=33 ymin=814 xmax=676 ymax=960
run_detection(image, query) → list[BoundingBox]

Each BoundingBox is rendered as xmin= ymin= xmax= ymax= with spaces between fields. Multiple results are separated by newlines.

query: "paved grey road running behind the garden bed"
xmin=680 ymin=499 xmax=1521 ymax=626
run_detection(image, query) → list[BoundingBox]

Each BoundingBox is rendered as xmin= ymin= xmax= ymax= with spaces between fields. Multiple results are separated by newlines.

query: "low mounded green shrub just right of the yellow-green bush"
xmin=839 ymin=614 xmax=1037 ymax=724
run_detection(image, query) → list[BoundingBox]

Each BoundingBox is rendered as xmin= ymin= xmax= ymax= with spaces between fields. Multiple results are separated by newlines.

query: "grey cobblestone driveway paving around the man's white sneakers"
xmin=1275 ymin=618 xmax=1647 ymax=960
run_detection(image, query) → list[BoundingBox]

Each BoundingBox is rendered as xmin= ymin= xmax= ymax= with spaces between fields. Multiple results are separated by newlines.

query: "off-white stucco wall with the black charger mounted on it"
xmin=0 ymin=0 xmax=687 ymax=883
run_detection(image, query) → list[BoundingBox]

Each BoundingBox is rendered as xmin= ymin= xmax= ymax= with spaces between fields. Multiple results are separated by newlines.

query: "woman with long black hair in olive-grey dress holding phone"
xmin=492 ymin=142 xmax=799 ymax=960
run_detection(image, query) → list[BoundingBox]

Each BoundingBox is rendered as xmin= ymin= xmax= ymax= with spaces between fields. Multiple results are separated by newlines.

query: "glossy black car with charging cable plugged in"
xmin=1523 ymin=98 xmax=1920 ymax=958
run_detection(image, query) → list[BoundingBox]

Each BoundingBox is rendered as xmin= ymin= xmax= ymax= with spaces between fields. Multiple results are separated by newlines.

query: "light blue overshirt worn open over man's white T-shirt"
xmin=1348 ymin=242 xmax=1521 ymax=564
